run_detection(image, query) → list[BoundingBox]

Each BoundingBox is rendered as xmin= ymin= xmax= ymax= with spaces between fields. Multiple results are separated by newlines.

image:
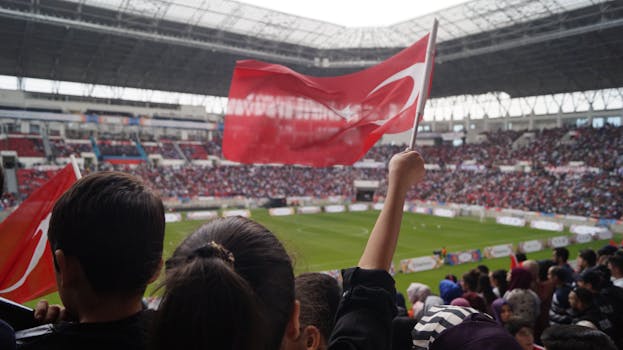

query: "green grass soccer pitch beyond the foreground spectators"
xmin=27 ymin=209 xmax=621 ymax=306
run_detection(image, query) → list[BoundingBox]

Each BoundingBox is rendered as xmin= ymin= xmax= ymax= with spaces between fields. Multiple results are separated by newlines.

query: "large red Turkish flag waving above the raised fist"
xmin=223 ymin=35 xmax=430 ymax=167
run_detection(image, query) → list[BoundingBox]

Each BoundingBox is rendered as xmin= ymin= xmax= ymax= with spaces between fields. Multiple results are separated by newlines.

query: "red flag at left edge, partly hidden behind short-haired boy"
xmin=0 ymin=164 xmax=77 ymax=303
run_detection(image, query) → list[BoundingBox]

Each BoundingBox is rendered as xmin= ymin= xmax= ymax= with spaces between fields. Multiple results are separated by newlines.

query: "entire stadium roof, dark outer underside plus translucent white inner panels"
xmin=0 ymin=0 xmax=623 ymax=97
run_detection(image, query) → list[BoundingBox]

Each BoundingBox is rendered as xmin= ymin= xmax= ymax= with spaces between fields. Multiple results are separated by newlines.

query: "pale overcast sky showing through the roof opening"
xmin=242 ymin=0 xmax=465 ymax=27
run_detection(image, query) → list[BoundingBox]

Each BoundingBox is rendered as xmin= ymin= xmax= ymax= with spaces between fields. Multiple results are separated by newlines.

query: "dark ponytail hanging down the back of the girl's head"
xmin=155 ymin=242 xmax=264 ymax=350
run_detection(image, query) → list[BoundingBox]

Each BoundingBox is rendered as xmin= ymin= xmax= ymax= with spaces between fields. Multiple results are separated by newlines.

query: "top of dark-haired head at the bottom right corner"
xmin=541 ymin=325 xmax=616 ymax=350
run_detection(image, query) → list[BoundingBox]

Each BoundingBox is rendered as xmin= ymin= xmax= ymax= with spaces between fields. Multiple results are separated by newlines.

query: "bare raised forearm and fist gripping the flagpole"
xmin=359 ymin=151 xmax=424 ymax=271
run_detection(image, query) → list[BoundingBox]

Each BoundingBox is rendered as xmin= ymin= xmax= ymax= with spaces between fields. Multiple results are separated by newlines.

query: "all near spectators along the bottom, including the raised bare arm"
xmin=0 ymin=152 xmax=623 ymax=350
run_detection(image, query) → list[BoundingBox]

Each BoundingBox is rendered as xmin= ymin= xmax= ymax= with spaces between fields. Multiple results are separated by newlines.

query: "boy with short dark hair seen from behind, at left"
xmin=17 ymin=172 xmax=164 ymax=349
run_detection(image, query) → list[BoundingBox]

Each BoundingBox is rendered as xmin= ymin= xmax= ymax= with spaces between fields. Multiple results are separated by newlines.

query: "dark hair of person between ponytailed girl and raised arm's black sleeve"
xmin=294 ymin=272 xmax=342 ymax=342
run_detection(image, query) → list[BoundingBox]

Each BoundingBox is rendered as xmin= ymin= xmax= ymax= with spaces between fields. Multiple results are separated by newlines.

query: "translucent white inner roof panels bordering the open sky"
xmin=40 ymin=0 xmax=608 ymax=49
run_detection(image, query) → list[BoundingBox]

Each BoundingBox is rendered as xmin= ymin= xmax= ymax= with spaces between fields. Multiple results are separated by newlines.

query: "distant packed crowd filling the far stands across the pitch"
xmin=7 ymin=126 xmax=623 ymax=219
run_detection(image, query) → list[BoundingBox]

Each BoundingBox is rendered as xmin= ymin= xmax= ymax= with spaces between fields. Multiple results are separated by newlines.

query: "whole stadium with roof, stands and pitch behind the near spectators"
xmin=0 ymin=0 xmax=623 ymax=348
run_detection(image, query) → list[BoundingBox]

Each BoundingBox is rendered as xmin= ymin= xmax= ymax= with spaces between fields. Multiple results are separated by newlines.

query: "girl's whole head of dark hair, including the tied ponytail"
xmin=151 ymin=217 xmax=294 ymax=349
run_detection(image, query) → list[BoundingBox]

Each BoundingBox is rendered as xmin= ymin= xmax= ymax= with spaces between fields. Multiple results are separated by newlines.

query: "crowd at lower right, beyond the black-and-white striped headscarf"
xmin=398 ymin=245 xmax=623 ymax=350
